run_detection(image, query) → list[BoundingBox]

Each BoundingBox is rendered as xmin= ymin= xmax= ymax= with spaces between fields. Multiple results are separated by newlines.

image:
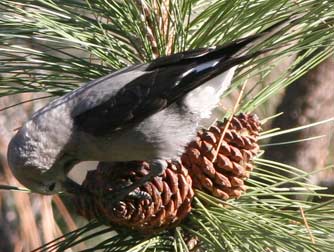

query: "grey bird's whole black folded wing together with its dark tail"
xmin=73 ymin=16 xmax=289 ymax=136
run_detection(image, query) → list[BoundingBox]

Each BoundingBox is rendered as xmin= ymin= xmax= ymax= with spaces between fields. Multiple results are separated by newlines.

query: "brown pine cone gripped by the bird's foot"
xmin=76 ymin=162 xmax=194 ymax=234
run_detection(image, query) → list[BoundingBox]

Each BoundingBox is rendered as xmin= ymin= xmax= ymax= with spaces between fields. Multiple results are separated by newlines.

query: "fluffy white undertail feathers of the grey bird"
xmin=185 ymin=66 xmax=236 ymax=119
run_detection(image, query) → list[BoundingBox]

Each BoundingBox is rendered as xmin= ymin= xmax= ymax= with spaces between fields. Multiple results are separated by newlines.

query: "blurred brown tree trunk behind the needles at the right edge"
xmin=266 ymin=57 xmax=334 ymax=186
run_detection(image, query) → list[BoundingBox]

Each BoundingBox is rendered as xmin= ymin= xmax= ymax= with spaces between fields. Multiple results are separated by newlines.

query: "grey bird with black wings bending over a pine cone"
xmin=7 ymin=17 xmax=289 ymax=201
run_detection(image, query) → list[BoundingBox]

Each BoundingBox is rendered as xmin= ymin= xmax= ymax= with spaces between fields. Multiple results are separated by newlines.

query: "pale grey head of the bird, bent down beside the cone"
xmin=7 ymin=128 xmax=79 ymax=195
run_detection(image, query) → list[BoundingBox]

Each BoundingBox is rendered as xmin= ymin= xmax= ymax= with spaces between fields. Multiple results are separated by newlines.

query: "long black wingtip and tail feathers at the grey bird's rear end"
xmin=148 ymin=15 xmax=300 ymax=103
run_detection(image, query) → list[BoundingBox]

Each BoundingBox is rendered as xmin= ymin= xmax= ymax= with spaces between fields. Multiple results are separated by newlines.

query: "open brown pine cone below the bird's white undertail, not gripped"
xmin=181 ymin=114 xmax=261 ymax=200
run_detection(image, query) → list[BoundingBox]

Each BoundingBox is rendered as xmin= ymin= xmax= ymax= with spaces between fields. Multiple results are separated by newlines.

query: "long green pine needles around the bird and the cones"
xmin=0 ymin=0 xmax=334 ymax=251
